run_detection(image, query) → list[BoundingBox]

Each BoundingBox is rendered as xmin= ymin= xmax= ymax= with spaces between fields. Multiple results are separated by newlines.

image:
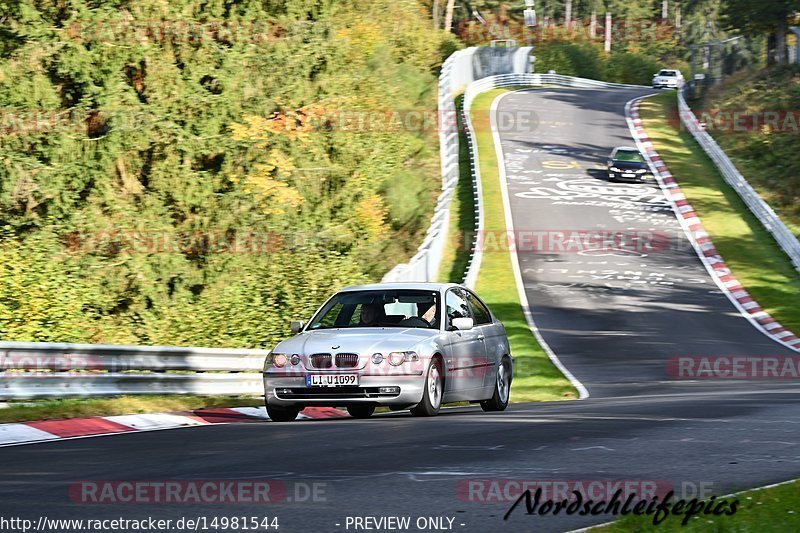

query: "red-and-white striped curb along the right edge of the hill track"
xmin=625 ymin=97 xmax=800 ymax=352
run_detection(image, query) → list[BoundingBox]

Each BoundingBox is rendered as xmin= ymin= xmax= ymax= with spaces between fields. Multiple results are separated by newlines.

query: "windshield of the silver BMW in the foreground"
xmin=308 ymin=290 xmax=439 ymax=330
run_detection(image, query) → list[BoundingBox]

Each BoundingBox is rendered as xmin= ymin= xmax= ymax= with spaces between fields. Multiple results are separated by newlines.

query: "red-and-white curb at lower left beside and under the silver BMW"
xmin=0 ymin=407 xmax=347 ymax=447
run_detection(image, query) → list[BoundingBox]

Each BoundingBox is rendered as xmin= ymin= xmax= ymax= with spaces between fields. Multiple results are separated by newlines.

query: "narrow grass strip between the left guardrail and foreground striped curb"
xmin=0 ymin=395 xmax=264 ymax=423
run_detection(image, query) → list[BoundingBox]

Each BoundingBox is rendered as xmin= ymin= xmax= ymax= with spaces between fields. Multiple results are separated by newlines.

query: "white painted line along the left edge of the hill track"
xmin=489 ymin=89 xmax=589 ymax=400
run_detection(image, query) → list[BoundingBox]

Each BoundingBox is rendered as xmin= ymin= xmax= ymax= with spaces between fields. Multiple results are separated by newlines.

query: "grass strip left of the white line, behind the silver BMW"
xmin=471 ymin=89 xmax=578 ymax=402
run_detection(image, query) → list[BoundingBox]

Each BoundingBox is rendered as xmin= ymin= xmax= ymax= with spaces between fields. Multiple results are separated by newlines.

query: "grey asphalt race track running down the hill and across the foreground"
xmin=0 ymin=89 xmax=800 ymax=532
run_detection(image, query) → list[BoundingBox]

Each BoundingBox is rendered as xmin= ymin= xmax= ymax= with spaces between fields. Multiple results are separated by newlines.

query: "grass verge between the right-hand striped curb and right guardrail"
xmin=639 ymin=92 xmax=800 ymax=333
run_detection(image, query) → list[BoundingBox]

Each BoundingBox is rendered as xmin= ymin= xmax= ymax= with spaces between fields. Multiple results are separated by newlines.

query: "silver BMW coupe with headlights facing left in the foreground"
xmin=264 ymin=283 xmax=514 ymax=422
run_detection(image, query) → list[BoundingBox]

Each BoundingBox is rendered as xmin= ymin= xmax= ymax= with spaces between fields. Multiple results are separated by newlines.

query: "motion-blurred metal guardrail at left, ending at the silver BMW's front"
xmin=0 ymin=342 xmax=269 ymax=400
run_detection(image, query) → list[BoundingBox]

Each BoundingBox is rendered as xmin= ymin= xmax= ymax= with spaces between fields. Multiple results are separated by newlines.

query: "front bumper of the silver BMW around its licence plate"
xmin=263 ymin=371 xmax=425 ymax=407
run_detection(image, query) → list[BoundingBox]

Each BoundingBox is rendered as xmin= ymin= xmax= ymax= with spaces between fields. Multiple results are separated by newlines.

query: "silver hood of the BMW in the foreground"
xmin=273 ymin=328 xmax=439 ymax=355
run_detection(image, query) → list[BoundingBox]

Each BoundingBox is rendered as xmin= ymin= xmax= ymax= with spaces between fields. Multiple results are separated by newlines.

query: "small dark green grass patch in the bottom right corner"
xmin=592 ymin=480 xmax=800 ymax=533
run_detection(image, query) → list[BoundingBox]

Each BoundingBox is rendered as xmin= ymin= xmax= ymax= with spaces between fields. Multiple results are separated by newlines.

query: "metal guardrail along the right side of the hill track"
xmin=678 ymin=92 xmax=800 ymax=272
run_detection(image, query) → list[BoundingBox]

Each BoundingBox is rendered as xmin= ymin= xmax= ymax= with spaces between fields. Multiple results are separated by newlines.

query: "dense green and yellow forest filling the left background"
xmin=0 ymin=0 xmax=457 ymax=346
